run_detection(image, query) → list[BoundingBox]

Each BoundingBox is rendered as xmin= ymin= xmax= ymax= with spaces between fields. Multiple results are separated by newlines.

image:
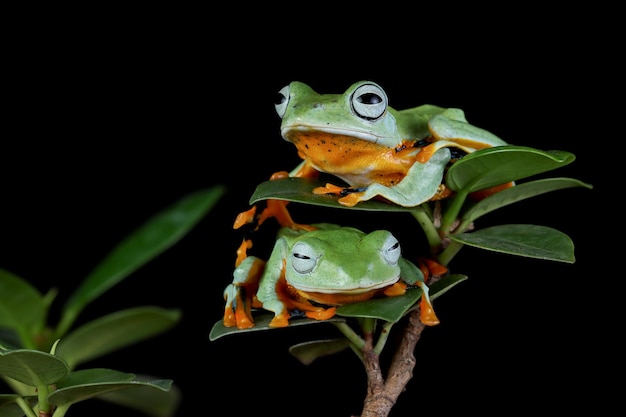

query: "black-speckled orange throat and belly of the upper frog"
xmin=291 ymin=132 xmax=419 ymax=186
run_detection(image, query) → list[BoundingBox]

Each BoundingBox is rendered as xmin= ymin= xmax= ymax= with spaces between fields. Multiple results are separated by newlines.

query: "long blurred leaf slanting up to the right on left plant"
xmin=57 ymin=186 xmax=224 ymax=338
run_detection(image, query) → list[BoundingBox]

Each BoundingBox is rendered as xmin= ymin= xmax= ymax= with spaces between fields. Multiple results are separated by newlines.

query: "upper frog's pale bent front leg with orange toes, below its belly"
xmin=324 ymin=148 xmax=450 ymax=207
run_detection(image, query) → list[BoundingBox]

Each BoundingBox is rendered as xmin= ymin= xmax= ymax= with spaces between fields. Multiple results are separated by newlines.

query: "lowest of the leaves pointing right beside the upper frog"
xmin=449 ymin=224 xmax=575 ymax=263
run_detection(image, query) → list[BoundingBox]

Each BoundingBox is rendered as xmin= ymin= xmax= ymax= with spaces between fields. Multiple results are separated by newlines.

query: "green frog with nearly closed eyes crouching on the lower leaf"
xmin=223 ymin=223 xmax=447 ymax=329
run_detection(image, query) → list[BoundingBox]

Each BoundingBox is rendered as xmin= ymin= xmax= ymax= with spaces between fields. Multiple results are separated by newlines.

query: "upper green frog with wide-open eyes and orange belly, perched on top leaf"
xmin=235 ymin=81 xmax=506 ymax=232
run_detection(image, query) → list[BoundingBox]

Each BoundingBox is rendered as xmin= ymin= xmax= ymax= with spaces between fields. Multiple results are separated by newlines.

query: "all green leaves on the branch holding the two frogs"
xmin=209 ymin=145 xmax=593 ymax=364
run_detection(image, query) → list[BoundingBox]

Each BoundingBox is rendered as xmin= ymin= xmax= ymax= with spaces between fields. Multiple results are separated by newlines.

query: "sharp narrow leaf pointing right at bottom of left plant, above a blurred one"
xmin=48 ymin=368 xmax=172 ymax=408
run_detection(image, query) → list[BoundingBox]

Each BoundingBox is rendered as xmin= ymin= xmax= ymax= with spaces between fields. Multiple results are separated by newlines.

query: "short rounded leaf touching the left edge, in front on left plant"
xmin=0 ymin=349 xmax=70 ymax=386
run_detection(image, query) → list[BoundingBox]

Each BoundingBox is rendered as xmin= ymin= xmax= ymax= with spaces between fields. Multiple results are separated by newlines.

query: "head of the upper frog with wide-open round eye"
xmin=276 ymin=81 xmax=401 ymax=147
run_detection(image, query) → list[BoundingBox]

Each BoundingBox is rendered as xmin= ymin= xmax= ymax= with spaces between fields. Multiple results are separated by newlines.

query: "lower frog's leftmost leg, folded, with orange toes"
xmin=223 ymin=256 xmax=265 ymax=329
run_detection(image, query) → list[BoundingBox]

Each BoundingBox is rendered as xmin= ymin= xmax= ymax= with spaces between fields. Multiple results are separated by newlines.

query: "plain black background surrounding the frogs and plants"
xmin=0 ymin=11 xmax=610 ymax=417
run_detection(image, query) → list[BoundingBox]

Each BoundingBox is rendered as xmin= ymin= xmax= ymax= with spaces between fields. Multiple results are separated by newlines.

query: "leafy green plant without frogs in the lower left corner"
xmin=0 ymin=186 xmax=224 ymax=417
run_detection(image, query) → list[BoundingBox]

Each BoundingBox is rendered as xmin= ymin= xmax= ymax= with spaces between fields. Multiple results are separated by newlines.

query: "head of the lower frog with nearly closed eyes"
xmin=285 ymin=227 xmax=401 ymax=305
